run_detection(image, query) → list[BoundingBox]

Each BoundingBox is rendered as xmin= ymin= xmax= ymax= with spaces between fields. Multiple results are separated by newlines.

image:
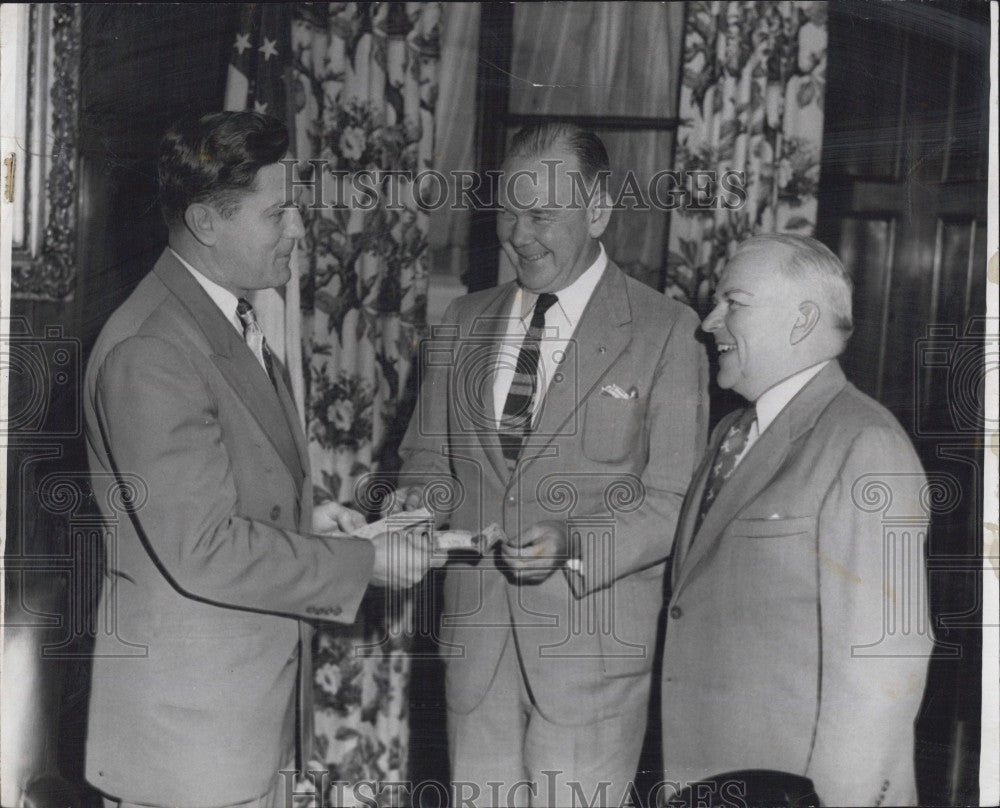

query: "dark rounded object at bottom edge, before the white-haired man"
xmin=665 ymin=769 xmax=819 ymax=808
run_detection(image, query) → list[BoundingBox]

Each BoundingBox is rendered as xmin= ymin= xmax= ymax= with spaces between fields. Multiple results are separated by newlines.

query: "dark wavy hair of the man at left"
xmin=157 ymin=112 xmax=288 ymax=225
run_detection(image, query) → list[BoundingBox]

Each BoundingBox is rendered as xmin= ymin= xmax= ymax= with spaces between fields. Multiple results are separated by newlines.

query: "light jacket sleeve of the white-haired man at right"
xmin=806 ymin=428 xmax=933 ymax=805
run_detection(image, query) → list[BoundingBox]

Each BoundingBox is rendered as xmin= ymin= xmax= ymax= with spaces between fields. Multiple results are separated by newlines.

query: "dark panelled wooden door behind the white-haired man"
xmin=818 ymin=2 xmax=989 ymax=805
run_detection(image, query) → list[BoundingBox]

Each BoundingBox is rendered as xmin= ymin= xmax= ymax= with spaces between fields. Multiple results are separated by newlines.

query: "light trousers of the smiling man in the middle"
xmin=448 ymin=636 xmax=649 ymax=808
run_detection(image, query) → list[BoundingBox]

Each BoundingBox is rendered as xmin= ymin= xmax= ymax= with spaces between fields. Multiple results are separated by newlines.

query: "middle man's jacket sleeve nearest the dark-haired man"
xmin=398 ymin=302 xmax=458 ymax=522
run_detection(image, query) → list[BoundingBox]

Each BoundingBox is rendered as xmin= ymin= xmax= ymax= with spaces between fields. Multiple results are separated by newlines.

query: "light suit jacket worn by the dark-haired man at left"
xmin=85 ymin=251 xmax=373 ymax=806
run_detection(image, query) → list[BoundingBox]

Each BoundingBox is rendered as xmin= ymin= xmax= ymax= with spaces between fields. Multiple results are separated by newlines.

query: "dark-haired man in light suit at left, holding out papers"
xmin=85 ymin=112 xmax=426 ymax=808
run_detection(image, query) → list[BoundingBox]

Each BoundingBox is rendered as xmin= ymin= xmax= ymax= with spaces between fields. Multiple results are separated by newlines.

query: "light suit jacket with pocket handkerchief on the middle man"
xmin=400 ymin=262 xmax=707 ymax=724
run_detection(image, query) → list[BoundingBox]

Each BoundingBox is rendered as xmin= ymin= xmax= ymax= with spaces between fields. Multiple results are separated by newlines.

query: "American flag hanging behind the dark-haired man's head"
xmin=224 ymin=3 xmax=305 ymax=423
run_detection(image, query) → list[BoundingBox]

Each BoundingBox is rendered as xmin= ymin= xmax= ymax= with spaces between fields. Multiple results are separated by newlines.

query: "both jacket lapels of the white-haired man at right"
xmin=674 ymin=361 xmax=846 ymax=593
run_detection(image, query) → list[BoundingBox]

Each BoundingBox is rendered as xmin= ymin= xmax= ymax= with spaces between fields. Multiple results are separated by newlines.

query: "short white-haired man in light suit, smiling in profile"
xmin=662 ymin=230 xmax=933 ymax=805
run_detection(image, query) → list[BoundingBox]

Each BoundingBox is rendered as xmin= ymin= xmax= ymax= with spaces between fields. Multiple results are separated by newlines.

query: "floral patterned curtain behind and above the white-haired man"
xmin=666 ymin=0 xmax=827 ymax=305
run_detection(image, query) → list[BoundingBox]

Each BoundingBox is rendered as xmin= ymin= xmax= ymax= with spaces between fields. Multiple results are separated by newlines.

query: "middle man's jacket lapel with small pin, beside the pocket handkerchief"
xmin=521 ymin=261 xmax=632 ymax=464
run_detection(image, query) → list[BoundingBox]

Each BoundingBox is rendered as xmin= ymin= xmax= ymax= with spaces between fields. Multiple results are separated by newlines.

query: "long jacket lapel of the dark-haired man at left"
xmin=153 ymin=250 xmax=305 ymax=481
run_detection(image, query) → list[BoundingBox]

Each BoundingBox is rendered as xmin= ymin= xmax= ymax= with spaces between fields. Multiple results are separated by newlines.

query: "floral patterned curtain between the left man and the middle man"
xmin=292 ymin=3 xmax=441 ymax=804
